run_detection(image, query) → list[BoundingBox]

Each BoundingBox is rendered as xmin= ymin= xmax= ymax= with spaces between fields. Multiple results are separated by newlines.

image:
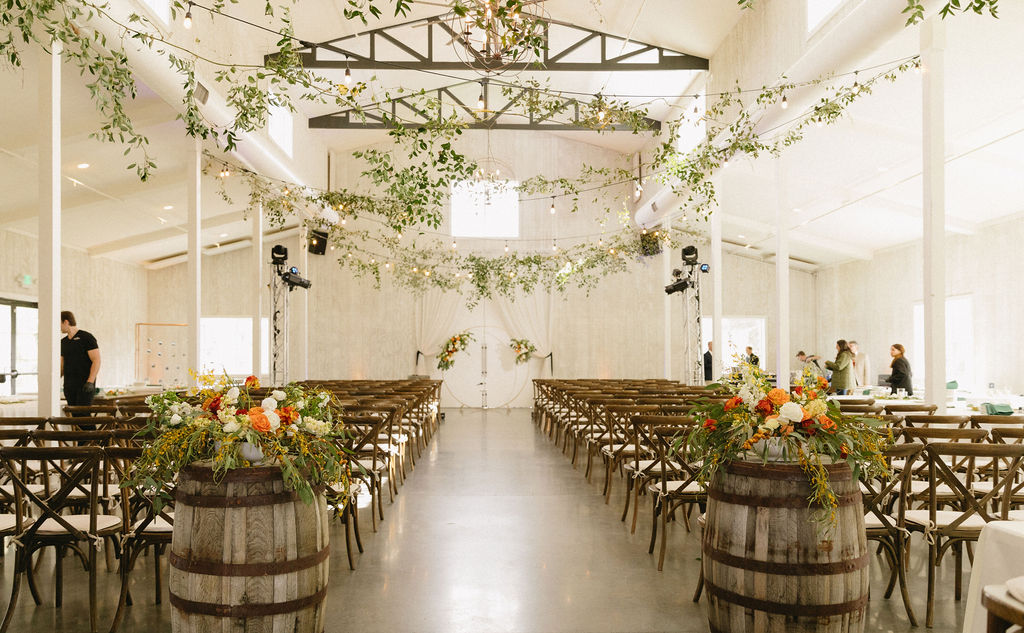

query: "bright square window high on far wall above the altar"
xmin=452 ymin=180 xmax=519 ymax=238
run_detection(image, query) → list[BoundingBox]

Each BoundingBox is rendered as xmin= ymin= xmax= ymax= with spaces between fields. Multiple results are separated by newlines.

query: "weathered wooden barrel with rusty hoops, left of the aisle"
xmin=168 ymin=465 xmax=331 ymax=633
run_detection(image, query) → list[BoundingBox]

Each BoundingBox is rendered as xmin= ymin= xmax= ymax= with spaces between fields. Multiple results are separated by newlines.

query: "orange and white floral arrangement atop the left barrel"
xmin=125 ymin=374 xmax=348 ymax=510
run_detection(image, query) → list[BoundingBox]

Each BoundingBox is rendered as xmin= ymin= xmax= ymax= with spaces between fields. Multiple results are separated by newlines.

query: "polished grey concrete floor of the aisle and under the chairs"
xmin=0 ymin=411 xmax=967 ymax=633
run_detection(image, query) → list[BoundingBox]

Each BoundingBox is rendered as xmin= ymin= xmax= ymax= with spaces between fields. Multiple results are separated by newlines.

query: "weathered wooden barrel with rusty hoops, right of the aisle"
xmin=702 ymin=462 xmax=868 ymax=633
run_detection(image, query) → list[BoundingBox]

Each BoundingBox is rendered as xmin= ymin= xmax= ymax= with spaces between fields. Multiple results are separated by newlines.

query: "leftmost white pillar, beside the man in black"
xmin=37 ymin=41 xmax=62 ymax=417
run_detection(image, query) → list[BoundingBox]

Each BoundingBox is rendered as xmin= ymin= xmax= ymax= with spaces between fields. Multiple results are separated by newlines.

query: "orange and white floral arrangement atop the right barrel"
xmin=684 ymin=363 xmax=892 ymax=528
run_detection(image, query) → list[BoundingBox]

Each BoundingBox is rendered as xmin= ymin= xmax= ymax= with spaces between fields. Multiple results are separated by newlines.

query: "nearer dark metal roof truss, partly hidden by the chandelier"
xmin=266 ymin=13 xmax=708 ymax=73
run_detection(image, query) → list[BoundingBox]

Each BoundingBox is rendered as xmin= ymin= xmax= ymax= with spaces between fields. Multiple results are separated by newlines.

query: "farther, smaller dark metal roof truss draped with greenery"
xmin=309 ymin=79 xmax=662 ymax=132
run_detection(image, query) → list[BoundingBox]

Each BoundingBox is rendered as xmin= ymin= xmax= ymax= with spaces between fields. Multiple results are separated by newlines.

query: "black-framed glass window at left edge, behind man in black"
xmin=0 ymin=299 xmax=39 ymax=395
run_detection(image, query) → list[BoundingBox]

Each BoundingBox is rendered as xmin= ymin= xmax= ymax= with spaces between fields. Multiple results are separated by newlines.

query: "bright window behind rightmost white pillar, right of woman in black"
xmin=904 ymin=295 xmax=977 ymax=389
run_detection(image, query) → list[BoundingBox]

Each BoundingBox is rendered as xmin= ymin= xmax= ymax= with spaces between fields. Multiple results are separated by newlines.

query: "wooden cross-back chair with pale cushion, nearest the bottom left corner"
xmin=0 ymin=447 xmax=121 ymax=633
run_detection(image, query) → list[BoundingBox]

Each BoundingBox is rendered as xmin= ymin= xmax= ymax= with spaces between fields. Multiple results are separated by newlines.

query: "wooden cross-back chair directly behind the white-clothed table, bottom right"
xmin=900 ymin=442 xmax=1024 ymax=627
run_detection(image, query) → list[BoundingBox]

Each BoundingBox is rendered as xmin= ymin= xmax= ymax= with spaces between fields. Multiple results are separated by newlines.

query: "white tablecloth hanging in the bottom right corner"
xmin=964 ymin=521 xmax=1024 ymax=633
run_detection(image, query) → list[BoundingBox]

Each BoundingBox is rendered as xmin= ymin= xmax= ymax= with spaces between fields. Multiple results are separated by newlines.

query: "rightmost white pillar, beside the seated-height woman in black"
xmin=921 ymin=15 xmax=946 ymax=414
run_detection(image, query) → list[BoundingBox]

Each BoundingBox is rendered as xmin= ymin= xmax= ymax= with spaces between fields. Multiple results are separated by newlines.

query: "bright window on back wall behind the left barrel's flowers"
xmin=199 ymin=317 xmax=270 ymax=376
